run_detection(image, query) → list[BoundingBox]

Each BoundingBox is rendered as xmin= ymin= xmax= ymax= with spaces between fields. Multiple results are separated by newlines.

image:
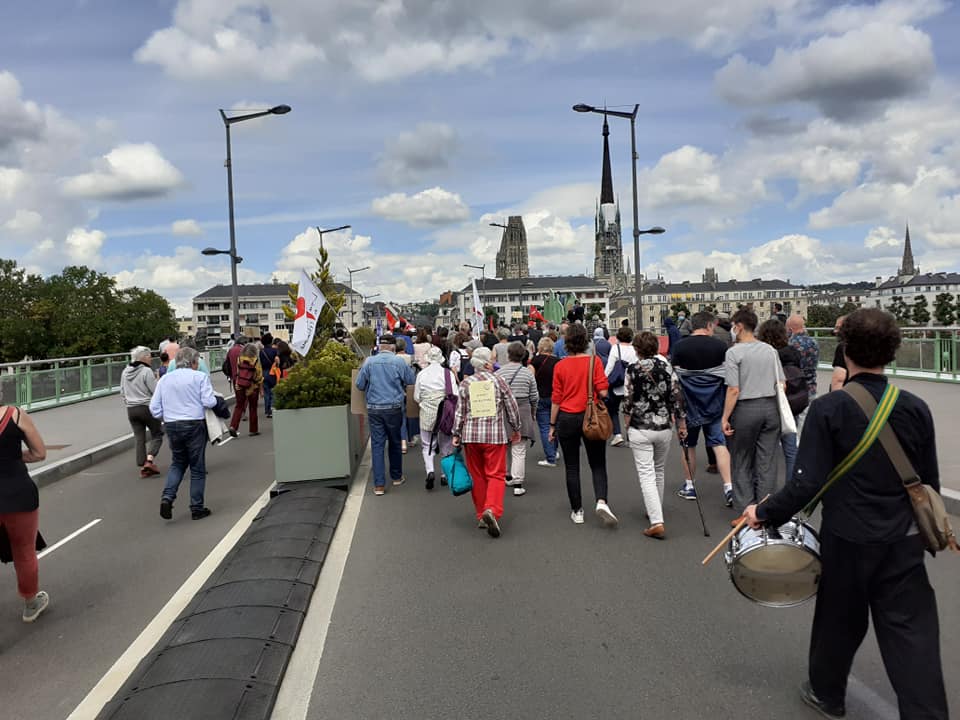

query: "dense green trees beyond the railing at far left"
xmin=0 ymin=260 xmax=177 ymax=362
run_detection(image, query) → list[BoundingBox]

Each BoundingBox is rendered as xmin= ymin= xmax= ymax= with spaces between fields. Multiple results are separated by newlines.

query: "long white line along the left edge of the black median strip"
xmin=67 ymin=483 xmax=273 ymax=720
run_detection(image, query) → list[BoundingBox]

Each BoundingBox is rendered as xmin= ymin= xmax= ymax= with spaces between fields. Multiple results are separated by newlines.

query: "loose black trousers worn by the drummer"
xmin=810 ymin=531 xmax=949 ymax=720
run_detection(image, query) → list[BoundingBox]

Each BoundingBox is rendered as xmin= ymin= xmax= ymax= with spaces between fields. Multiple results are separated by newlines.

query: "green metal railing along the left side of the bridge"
xmin=0 ymin=348 xmax=226 ymax=410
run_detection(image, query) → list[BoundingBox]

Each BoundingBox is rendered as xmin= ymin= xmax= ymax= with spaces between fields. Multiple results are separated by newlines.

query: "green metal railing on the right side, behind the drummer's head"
xmin=807 ymin=327 xmax=960 ymax=383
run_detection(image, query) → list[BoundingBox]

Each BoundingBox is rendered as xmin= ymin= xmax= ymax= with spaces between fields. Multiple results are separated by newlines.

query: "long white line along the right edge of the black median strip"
xmin=272 ymin=444 xmax=370 ymax=720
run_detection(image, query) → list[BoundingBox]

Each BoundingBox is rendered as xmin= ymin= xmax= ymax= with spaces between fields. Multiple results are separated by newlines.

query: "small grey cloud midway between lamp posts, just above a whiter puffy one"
xmin=377 ymin=122 xmax=459 ymax=186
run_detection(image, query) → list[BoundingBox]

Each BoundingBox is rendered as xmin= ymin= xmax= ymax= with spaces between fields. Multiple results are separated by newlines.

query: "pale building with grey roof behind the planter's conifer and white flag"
xmin=193 ymin=281 xmax=363 ymax=348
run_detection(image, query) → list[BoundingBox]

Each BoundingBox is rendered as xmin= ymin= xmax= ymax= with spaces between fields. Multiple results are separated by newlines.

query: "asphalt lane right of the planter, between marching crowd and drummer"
xmin=300 ymin=436 xmax=960 ymax=720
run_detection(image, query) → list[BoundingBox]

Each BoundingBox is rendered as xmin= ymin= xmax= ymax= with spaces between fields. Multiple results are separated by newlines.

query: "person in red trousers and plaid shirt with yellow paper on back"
xmin=453 ymin=348 xmax=520 ymax=537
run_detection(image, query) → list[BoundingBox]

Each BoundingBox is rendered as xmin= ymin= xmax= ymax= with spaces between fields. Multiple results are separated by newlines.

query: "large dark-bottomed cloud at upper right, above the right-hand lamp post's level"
xmin=716 ymin=23 xmax=935 ymax=119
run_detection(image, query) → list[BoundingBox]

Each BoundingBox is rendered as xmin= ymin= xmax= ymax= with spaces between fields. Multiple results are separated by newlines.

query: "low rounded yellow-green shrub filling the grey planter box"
xmin=273 ymin=340 xmax=359 ymax=410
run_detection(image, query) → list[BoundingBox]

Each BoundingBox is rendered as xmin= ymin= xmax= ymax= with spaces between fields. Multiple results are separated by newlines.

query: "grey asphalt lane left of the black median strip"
xmin=0 ymin=422 xmax=274 ymax=720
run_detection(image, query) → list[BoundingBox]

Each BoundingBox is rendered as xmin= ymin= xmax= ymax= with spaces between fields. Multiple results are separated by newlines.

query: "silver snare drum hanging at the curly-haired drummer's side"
xmin=723 ymin=518 xmax=820 ymax=607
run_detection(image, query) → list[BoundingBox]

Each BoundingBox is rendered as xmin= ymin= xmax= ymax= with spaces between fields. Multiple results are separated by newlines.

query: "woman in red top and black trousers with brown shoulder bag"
xmin=549 ymin=323 xmax=617 ymax=527
